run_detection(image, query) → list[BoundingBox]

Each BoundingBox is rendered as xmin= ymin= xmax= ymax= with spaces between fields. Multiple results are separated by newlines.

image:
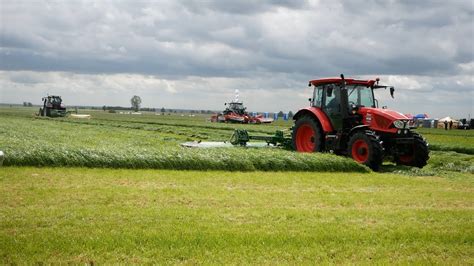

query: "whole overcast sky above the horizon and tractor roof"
xmin=0 ymin=0 xmax=474 ymax=118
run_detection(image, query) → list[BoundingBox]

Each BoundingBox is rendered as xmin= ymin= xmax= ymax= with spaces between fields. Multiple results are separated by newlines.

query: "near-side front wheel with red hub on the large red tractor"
xmin=347 ymin=131 xmax=384 ymax=171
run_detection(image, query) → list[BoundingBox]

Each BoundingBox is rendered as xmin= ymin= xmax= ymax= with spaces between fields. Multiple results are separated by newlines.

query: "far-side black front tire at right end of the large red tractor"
xmin=395 ymin=133 xmax=430 ymax=168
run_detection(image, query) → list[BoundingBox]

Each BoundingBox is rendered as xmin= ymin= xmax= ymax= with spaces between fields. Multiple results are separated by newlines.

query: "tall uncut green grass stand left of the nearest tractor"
xmin=0 ymin=112 xmax=368 ymax=172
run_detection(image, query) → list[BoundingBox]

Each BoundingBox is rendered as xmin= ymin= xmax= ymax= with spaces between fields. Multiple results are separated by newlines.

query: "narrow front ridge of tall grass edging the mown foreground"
xmin=4 ymin=147 xmax=369 ymax=172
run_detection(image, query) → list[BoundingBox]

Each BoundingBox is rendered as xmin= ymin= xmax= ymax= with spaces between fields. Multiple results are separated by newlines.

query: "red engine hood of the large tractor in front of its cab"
xmin=358 ymin=107 xmax=410 ymax=131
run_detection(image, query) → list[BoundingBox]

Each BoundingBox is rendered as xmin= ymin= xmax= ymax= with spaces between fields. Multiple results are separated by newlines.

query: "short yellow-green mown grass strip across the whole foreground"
xmin=0 ymin=167 xmax=474 ymax=264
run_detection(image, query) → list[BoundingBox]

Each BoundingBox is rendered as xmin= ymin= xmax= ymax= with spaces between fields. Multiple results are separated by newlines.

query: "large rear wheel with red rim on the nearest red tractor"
xmin=292 ymin=115 xmax=323 ymax=152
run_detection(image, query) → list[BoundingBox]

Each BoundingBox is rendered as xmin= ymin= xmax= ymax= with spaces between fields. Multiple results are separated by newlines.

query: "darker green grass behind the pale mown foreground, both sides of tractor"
xmin=0 ymin=108 xmax=474 ymax=175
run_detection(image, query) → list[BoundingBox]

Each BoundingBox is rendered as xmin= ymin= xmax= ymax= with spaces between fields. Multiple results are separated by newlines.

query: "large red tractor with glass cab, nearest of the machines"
xmin=292 ymin=75 xmax=429 ymax=171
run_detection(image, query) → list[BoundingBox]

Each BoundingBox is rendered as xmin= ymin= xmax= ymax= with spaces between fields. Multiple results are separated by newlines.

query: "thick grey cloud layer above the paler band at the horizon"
xmin=0 ymin=1 xmax=473 ymax=76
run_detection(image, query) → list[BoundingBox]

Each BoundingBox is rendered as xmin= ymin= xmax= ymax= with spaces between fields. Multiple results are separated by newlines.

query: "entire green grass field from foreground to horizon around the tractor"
xmin=0 ymin=107 xmax=474 ymax=265
